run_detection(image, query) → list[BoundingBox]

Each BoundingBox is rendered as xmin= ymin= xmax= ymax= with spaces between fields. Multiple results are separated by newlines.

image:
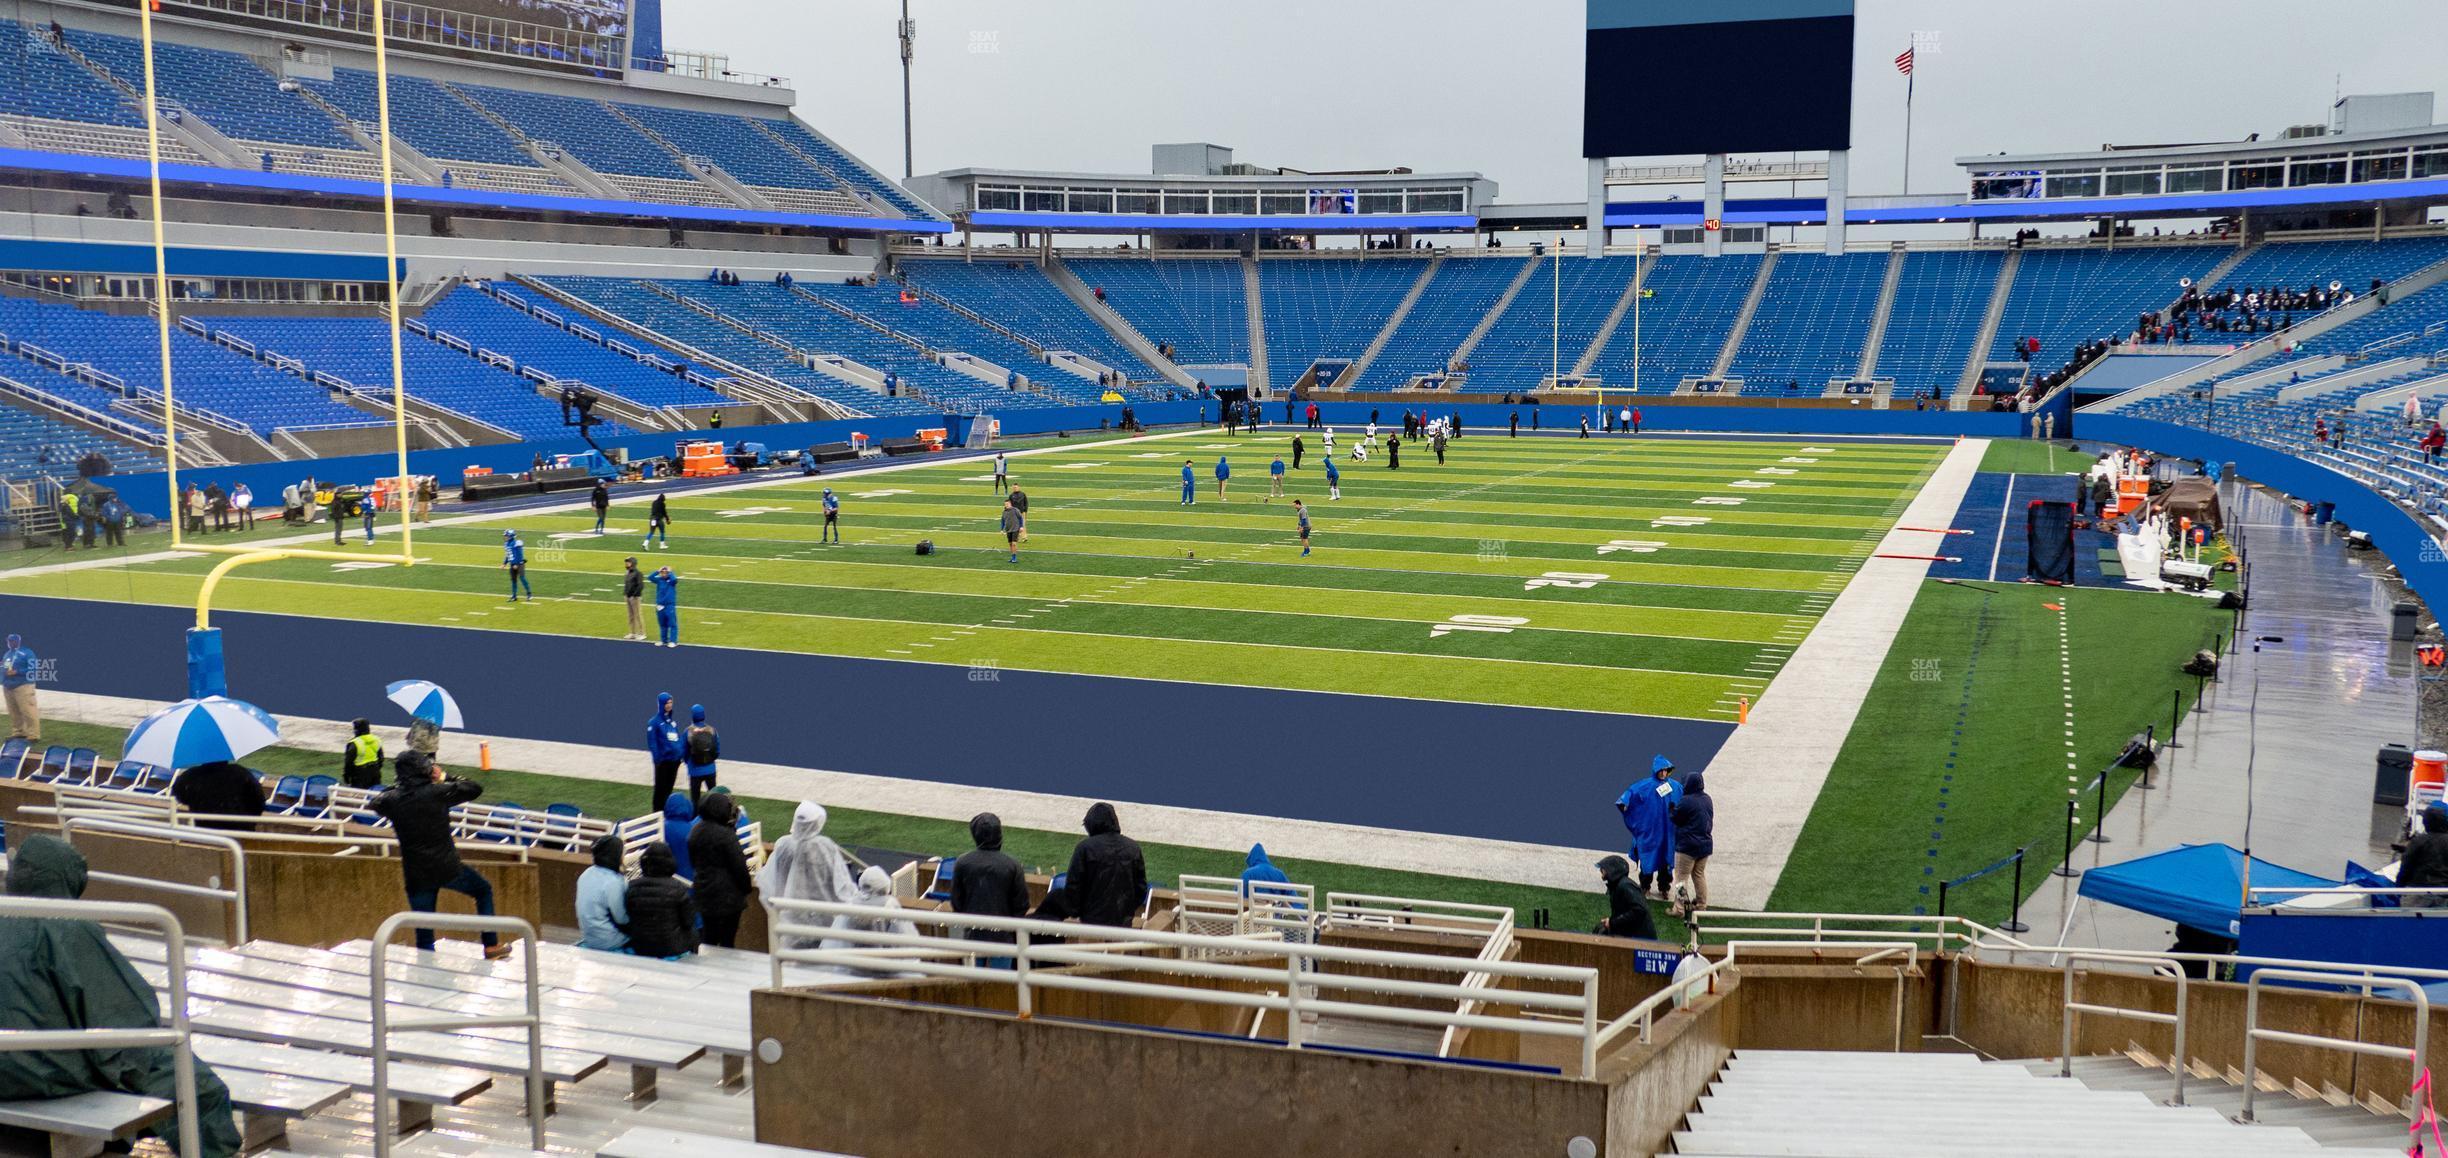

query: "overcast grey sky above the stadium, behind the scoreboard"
xmin=663 ymin=0 xmax=2448 ymax=201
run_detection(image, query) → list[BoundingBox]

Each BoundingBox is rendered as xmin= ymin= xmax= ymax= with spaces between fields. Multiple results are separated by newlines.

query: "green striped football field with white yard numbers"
xmin=0 ymin=428 xmax=1946 ymax=720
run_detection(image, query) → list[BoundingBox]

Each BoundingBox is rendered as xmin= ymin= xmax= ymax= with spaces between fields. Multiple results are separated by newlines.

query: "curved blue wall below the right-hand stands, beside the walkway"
xmin=2081 ymin=414 xmax=2448 ymax=612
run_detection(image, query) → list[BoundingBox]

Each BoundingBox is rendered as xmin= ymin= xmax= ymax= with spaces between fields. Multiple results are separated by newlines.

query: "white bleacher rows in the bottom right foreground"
xmin=1674 ymin=1050 xmax=2404 ymax=1158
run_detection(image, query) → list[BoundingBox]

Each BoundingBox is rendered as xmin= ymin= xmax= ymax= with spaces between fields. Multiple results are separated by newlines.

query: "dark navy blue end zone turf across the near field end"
xmin=0 ymin=595 xmax=1733 ymax=850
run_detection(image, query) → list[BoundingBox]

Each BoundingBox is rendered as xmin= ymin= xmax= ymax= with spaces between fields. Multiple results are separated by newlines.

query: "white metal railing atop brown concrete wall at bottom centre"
xmin=766 ymin=898 xmax=1599 ymax=1077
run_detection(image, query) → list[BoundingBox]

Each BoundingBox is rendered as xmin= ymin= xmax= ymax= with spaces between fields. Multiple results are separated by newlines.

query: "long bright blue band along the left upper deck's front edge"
xmin=0 ymin=147 xmax=952 ymax=235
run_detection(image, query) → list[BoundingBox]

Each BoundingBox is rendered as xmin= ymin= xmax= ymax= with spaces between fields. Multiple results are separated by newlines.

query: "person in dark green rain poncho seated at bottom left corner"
xmin=0 ymin=835 xmax=237 ymax=1158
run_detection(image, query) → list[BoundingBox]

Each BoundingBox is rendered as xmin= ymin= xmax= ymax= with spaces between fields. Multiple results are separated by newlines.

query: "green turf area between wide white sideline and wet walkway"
xmin=1770 ymin=583 xmax=2235 ymax=923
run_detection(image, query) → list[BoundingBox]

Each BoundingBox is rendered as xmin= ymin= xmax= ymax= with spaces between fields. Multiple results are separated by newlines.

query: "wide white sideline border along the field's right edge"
xmin=1709 ymin=438 xmax=1988 ymax=908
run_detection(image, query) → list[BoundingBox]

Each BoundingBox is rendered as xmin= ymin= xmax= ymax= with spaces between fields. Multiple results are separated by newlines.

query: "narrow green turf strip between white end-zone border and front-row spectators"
xmin=23 ymin=720 xmax=1684 ymax=940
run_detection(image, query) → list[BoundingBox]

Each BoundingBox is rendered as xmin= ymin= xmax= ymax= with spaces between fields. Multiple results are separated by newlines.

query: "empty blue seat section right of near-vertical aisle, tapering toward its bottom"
xmin=1258 ymin=257 xmax=1427 ymax=387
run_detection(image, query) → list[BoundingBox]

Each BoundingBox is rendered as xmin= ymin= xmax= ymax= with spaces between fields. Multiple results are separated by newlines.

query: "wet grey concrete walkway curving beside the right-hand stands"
xmin=2022 ymin=482 xmax=2416 ymax=950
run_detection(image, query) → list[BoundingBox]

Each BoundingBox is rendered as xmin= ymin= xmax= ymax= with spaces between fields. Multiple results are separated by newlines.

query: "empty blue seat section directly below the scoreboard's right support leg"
xmin=1726 ymin=250 xmax=1890 ymax=394
